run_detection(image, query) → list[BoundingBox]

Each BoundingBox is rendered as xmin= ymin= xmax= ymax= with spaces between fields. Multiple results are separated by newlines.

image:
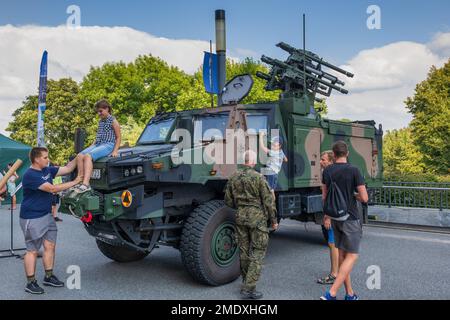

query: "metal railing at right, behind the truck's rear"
xmin=368 ymin=182 xmax=450 ymax=210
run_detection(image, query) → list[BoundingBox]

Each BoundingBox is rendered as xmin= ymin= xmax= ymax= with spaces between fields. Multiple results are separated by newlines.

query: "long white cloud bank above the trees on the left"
xmin=0 ymin=25 xmax=221 ymax=134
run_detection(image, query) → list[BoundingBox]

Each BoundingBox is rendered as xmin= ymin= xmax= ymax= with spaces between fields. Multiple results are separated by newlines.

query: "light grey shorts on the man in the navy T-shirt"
xmin=20 ymin=213 xmax=58 ymax=251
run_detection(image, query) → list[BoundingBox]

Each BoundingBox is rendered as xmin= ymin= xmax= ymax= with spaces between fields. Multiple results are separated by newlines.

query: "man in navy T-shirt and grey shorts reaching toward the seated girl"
xmin=20 ymin=147 xmax=81 ymax=294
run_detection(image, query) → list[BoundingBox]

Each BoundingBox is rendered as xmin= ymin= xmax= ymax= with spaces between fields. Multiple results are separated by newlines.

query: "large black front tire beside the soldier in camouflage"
xmin=180 ymin=200 xmax=240 ymax=286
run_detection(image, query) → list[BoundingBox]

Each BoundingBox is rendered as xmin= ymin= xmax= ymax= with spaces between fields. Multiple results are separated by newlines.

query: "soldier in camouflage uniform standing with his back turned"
xmin=225 ymin=151 xmax=278 ymax=299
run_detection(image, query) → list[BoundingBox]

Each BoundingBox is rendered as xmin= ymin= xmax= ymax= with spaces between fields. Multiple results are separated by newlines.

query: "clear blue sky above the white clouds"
xmin=0 ymin=0 xmax=450 ymax=63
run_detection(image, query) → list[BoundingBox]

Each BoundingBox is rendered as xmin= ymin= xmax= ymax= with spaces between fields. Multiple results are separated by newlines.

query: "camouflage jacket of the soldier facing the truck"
xmin=225 ymin=167 xmax=277 ymax=227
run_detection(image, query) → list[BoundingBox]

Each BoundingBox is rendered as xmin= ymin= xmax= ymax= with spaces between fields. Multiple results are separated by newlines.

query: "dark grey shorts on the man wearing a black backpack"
xmin=331 ymin=220 xmax=362 ymax=253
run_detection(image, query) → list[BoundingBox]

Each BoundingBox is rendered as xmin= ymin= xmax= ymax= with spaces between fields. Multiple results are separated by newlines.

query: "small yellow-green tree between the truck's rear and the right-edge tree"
xmin=383 ymin=128 xmax=425 ymax=177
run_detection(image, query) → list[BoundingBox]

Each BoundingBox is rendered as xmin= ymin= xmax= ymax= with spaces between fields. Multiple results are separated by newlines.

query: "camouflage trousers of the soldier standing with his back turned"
xmin=236 ymin=224 xmax=269 ymax=290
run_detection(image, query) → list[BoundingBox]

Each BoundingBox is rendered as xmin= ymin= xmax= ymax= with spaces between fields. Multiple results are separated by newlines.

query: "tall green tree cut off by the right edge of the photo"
xmin=405 ymin=59 xmax=450 ymax=174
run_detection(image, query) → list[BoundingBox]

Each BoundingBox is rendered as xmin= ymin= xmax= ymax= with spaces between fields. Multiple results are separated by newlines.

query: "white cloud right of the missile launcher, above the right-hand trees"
xmin=327 ymin=33 xmax=450 ymax=129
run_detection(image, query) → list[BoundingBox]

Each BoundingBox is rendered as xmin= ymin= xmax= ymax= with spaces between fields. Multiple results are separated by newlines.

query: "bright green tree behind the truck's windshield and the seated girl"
xmin=80 ymin=55 xmax=193 ymax=125
